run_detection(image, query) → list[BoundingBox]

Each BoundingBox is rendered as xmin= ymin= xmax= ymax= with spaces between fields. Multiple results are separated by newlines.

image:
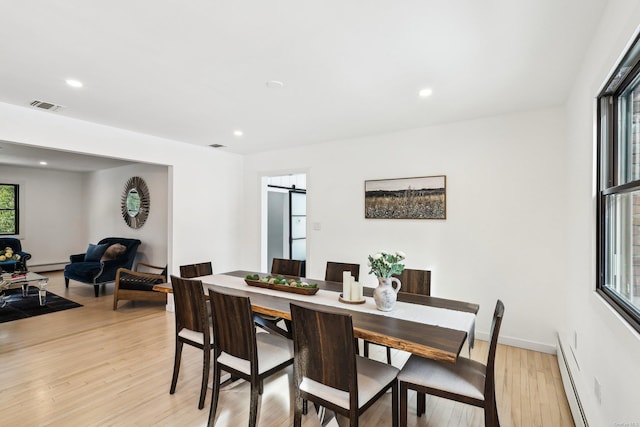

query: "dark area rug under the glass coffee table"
xmin=0 ymin=288 xmax=82 ymax=323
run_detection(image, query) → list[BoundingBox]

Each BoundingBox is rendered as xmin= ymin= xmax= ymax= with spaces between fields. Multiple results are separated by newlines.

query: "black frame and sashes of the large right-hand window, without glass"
xmin=596 ymin=35 xmax=640 ymax=332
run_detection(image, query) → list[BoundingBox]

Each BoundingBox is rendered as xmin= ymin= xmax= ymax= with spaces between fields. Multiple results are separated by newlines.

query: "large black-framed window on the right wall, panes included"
xmin=597 ymin=34 xmax=640 ymax=331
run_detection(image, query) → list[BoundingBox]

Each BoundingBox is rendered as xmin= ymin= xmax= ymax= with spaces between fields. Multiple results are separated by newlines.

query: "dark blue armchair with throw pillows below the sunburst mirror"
xmin=64 ymin=237 xmax=142 ymax=297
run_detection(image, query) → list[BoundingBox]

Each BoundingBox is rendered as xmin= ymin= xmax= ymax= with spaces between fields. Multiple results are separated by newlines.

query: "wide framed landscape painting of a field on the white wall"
xmin=364 ymin=175 xmax=447 ymax=219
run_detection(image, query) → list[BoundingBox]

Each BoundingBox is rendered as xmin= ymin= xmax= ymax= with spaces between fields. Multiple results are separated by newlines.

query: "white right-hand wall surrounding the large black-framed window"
xmin=559 ymin=1 xmax=640 ymax=426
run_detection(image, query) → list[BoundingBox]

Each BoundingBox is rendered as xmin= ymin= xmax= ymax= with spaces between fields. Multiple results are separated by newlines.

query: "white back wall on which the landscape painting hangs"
xmin=243 ymin=108 xmax=565 ymax=351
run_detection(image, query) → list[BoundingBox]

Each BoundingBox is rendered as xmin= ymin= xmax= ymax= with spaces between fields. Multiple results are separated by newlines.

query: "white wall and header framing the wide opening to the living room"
xmin=0 ymin=103 xmax=242 ymax=273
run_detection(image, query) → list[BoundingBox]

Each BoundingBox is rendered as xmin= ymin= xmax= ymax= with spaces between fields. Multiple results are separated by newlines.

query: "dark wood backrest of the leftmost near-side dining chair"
xmin=171 ymin=275 xmax=210 ymax=342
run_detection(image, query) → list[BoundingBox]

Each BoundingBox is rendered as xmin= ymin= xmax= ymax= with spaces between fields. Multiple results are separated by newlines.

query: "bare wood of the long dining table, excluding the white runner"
xmin=154 ymin=270 xmax=479 ymax=363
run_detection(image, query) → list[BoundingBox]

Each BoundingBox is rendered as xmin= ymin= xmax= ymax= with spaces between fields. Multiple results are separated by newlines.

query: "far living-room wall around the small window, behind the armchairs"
xmin=0 ymin=165 xmax=89 ymax=270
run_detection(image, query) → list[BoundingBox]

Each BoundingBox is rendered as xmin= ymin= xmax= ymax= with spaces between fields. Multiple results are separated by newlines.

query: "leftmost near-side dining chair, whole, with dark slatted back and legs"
xmin=170 ymin=275 xmax=213 ymax=409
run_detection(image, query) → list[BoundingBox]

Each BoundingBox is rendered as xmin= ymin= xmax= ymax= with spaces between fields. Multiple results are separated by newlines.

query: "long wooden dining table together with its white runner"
xmin=154 ymin=270 xmax=479 ymax=363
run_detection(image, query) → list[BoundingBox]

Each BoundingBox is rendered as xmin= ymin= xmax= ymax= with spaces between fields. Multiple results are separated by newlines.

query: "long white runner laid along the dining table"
xmin=198 ymin=274 xmax=476 ymax=349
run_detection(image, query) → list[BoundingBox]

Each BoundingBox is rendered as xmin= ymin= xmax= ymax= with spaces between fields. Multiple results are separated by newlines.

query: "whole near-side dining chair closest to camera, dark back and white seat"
xmin=291 ymin=303 xmax=399 ymax=427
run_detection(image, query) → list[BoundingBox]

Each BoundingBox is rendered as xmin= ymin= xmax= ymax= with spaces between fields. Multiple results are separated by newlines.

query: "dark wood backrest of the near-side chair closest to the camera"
xmin=291 ymin=304 xmax=358 ymax=398
